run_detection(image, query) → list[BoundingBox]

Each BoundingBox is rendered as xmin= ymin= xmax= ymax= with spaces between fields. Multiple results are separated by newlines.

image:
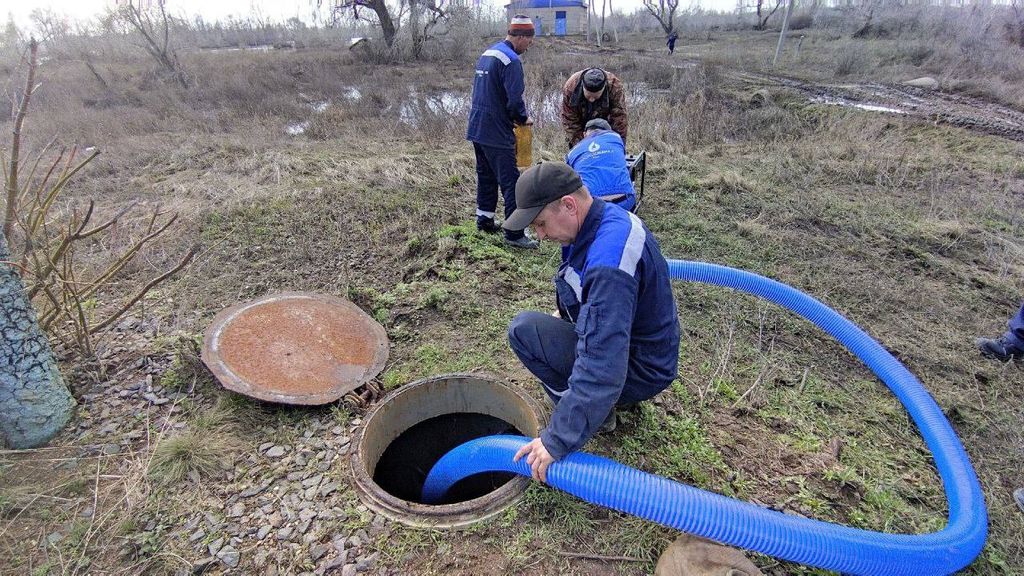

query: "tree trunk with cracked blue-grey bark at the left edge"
xmin=0 ymin=234 xmax=75 ymax=448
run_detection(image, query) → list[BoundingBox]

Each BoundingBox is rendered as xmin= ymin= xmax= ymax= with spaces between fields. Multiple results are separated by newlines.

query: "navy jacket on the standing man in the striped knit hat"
xmin=466 ymin=40 xmax=528 ymax=149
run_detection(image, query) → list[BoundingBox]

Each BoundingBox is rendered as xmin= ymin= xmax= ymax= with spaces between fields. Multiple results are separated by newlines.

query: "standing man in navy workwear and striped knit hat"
xmin=466 ymin=14 xmax=537 ymax=248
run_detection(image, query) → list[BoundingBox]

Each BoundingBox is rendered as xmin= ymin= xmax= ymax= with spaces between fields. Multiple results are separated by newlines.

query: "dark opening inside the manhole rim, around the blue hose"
xmin=374 ymin=412 xmax=522 ymax=504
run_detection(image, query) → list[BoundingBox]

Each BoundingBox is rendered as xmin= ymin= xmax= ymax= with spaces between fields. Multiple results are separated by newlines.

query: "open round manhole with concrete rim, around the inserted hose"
xmin=351 ymin=374 xmax=541 ymax=528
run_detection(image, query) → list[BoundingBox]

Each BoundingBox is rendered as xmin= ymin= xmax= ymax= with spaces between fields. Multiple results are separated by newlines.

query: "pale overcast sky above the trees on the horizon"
xmin=0 ymin=0 xmax=736 ymax=26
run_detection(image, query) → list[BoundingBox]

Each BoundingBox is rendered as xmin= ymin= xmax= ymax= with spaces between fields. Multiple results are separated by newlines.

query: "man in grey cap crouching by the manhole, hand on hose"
xmin=503 ymin=162 xmax=679 ymax=482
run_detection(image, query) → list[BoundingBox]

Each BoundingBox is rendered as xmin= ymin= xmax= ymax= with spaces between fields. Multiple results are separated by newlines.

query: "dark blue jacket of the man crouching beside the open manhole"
xmin=541 ymin=198 xmax=679 ymax=459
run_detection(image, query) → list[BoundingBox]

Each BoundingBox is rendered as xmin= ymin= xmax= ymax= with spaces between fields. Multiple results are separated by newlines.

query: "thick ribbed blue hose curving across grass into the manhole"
xmin=423 ymin=260 xmax=988 ymax=575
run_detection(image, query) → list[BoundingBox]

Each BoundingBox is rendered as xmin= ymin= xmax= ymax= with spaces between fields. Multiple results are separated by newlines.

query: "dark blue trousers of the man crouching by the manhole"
xmin=509 ymin=312 xmax=665 ymax=406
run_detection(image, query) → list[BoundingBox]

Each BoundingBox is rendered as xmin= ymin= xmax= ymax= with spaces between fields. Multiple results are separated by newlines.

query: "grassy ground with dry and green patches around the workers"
xmin=0 ymin=28 xmax=1024 ymax=575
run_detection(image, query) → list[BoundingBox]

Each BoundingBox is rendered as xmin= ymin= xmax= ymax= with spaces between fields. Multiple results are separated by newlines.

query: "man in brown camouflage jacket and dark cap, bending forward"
xmin=562 ymin=68 xmax=629 ymax=148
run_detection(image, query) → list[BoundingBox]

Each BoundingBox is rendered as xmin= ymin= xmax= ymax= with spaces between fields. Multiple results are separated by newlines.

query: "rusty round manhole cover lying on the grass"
xmin=203 ymin=292 xmax=388 ymax=404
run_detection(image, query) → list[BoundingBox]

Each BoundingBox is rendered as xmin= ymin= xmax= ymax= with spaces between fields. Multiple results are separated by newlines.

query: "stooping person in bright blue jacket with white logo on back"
xmin=565 ymin=118 xmax=637 ymax=212
